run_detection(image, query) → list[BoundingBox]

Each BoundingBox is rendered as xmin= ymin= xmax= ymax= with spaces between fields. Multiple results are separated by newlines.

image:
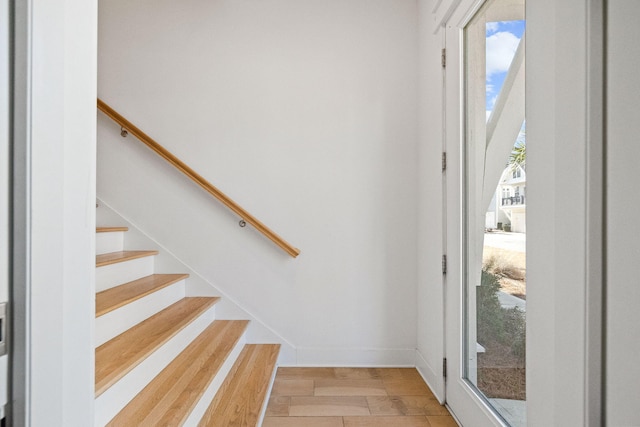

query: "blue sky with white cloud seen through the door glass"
xmin=486 ymin=21 xmax=525 ymax=113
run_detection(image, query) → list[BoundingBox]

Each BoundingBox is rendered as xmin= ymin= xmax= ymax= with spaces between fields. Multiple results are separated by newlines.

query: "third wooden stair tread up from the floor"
xmin=95 ymin=297 xmax=219 ymax=397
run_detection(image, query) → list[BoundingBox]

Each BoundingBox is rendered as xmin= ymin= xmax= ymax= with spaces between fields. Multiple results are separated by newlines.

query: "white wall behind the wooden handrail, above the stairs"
xmin=98 ymin=0 xmax=418 ymax=365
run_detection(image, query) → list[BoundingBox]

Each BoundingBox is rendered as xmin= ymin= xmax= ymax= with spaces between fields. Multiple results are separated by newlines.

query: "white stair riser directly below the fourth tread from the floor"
xmin=95 ymin=280 xmax=185 ymax=347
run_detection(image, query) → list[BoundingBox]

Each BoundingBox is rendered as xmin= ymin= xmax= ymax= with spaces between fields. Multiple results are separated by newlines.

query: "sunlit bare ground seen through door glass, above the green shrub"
xmin=482 ymin=246 xmax=527 ymax=300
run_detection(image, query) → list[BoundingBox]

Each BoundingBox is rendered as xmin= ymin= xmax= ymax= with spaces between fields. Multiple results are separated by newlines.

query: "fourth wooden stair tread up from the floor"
xmin=96 ymin=274 xmax=189 ymax=317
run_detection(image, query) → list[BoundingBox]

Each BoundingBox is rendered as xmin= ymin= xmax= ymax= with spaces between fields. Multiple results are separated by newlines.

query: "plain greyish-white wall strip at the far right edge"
xmin=606 ymin=0 xmax=640 ymax=426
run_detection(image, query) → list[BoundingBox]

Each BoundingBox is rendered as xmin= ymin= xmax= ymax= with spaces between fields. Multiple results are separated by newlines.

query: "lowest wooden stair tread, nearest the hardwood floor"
xmin=198 ymin=344 xmax=280 ymax=427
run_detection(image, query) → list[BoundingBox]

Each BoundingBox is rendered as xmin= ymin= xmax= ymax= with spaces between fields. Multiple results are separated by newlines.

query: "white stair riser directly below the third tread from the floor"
xmin=95 ymin=306 xmax=215 ymax=427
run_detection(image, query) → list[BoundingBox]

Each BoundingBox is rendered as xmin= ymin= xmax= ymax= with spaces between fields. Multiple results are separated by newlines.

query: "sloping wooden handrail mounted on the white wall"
xmin=98 ymin=99 xmax=300 ymax=258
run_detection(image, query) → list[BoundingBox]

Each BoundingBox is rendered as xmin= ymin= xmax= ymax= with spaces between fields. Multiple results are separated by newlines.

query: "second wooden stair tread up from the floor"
xmin=107 ymin=320 xmax=249 ymax=426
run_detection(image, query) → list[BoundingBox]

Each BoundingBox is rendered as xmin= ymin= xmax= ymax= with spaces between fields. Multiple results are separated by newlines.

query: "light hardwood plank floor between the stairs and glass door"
xmin=263 ymin=368 xmax=457 ymax=427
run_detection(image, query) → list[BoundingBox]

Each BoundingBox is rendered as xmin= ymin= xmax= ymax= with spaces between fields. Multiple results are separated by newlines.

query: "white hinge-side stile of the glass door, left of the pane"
xmin=444 ymin=0 xmax=505 ymax=427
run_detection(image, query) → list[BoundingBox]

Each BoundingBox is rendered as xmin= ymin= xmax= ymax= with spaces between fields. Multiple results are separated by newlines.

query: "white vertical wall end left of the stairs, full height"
xmin=13 ymin=0 xmax=97 ymax=426
